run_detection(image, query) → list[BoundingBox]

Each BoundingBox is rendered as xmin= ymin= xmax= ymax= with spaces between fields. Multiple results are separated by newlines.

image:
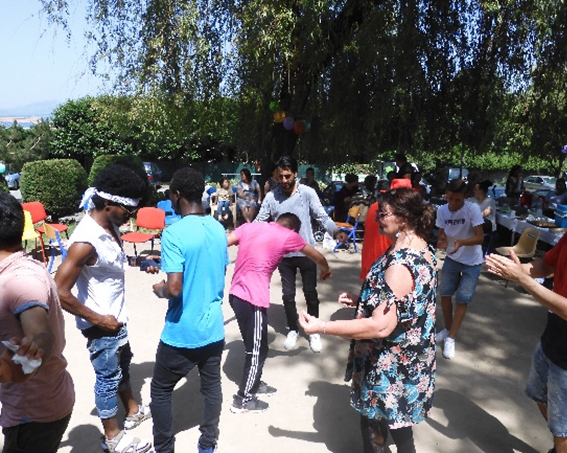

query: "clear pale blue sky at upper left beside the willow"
xmin=0 ymin=0 xmax=102 ymax=110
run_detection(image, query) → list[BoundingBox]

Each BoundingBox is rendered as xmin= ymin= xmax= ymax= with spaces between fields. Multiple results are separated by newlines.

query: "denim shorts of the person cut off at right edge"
xmin=526 ymin=343 xmax=567 ymax=437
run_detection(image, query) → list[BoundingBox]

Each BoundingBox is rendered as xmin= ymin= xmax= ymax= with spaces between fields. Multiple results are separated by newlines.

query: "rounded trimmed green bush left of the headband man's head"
xmin=20 ymin=159 xmax=87 ymax=220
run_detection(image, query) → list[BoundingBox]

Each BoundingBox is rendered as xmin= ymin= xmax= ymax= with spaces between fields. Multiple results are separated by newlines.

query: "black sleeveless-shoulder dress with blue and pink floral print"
xmin=345 ymin=248 xmax=437 ymax=429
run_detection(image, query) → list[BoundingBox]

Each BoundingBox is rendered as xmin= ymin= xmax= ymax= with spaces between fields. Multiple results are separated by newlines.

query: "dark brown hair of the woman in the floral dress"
xmin=380 ymin=188 xmax=435 ymax=240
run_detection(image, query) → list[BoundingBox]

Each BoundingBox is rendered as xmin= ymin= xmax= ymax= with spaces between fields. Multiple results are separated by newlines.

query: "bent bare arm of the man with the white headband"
xmin=55 ymin=242 xmax=122 ymax=332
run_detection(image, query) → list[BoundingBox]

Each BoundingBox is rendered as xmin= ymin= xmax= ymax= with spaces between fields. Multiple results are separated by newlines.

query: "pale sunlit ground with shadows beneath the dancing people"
xmin=4 ymin=238 xmax=551 ymax=453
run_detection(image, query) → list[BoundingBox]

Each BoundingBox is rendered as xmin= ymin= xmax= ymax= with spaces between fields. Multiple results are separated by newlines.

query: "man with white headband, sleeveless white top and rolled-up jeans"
xmin=55 ymin=165 xmax=151 ymax=453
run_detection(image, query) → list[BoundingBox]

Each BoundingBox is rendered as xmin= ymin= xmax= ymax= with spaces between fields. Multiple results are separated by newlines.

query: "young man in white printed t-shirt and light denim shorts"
xmin=436 ymin=179 xmax=484 ymax=359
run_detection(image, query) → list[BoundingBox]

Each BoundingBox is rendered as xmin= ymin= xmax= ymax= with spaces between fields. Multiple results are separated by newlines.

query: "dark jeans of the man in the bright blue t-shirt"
xmin=150 ymin=340 xmax=224 ymax=453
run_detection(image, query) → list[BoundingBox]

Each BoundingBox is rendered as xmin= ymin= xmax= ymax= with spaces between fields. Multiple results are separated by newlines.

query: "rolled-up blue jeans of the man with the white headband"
xmin=83 ymin=326 xmax=133 ymax=420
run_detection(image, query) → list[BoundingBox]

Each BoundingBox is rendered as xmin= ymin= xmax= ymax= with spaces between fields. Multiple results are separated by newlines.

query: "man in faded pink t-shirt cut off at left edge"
xmin=0 ymin=192 xmax=75 ymax=453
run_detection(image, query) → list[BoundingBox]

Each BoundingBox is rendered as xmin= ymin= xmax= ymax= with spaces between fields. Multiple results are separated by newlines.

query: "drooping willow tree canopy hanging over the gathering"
xmin=37 ymin=0 xmax=567 ymax=170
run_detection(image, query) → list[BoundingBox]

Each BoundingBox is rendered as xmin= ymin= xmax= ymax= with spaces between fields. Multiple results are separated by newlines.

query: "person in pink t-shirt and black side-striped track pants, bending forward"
xmin=228 ymin=213 xmax=331 ymax=413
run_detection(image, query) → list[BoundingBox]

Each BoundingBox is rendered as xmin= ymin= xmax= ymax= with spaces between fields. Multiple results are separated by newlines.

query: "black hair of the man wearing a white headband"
xmin=92 ymin=165 xmax=148 ymax=209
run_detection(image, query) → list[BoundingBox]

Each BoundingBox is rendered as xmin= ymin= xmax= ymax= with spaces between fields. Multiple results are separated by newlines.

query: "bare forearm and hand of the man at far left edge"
xmin=0 ymin=306 xmax=55 ymax=383
